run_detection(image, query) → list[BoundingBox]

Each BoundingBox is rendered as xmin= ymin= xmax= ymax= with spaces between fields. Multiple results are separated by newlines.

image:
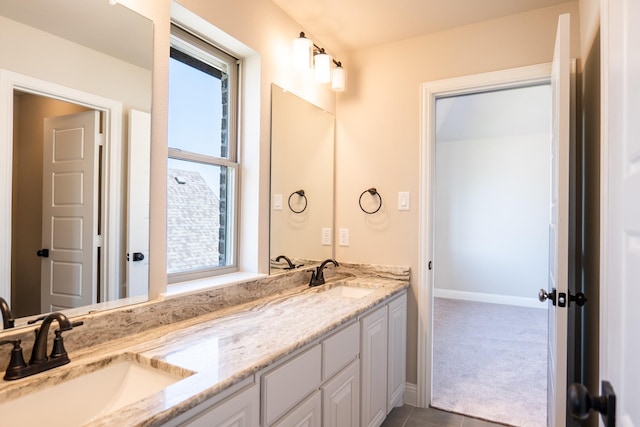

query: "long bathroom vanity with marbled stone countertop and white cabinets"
xmin=0 ymin=266 xmax=409 ymax=427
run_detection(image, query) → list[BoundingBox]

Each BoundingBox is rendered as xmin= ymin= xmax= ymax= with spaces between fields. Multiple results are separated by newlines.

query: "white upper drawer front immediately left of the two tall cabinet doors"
xmin=322 ymin=323 xmax=360 ymax=380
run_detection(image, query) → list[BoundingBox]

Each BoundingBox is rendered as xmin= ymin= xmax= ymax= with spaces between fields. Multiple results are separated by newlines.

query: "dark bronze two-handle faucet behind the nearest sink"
xmin=0 ymin=312 xmax=83 ymax=380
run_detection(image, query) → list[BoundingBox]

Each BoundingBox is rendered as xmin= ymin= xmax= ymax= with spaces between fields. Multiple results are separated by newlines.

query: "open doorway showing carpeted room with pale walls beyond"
xmin=431 ymin=83 xmax=551 ymax=427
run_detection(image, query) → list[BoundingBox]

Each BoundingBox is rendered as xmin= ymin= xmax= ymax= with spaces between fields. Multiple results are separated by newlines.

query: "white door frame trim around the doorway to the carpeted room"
xmin=416 ymin=64 xmax=551 ymax=408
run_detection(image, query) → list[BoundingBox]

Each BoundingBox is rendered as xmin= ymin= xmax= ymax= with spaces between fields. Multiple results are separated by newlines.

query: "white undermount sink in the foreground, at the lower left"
xmin=0 ymin=357 xmax=188 ymax=427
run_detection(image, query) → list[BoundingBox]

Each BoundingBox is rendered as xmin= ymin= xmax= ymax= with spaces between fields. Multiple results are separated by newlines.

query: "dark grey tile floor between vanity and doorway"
xmin=382 ymin=405 xmax=510 ymax=427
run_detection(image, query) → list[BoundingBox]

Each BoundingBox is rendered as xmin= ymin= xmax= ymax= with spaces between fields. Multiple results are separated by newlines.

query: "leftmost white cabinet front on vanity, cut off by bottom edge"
xmin=183 ymin=384 xmax=260 ymax=427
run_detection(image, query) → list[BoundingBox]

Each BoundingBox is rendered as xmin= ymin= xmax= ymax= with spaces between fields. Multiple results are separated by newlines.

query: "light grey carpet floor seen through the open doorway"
xmin=432 ymin=298 xmax=547 ymax=427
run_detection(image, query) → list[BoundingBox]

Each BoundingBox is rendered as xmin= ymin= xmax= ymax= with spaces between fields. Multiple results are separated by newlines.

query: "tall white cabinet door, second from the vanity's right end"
xmin=360 ymin=306 xmax=387 ymax=427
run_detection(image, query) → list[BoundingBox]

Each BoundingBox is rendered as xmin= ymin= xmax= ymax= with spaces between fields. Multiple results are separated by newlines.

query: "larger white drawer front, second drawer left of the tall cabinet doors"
xmin=262 ymin=344 xmax=322 ymax=426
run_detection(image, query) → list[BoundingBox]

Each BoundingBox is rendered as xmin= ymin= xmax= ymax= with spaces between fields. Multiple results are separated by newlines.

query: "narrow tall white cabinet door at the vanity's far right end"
xmin=387 ymin=294 xmax=407 ymax=413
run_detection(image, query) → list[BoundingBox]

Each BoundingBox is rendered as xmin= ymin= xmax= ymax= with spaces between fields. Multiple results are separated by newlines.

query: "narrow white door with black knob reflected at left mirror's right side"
xmin=122 ymin=110 xmax=151 ymax=297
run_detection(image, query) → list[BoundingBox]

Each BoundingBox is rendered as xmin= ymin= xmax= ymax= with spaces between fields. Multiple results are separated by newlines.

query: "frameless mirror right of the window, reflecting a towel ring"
xmin=270 ymin=85 xmax=335 ymax=274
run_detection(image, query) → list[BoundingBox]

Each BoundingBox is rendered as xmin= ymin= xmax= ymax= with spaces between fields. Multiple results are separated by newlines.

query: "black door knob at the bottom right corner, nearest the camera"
xmin=567 ymin=381 xmax=616 ymax=427
